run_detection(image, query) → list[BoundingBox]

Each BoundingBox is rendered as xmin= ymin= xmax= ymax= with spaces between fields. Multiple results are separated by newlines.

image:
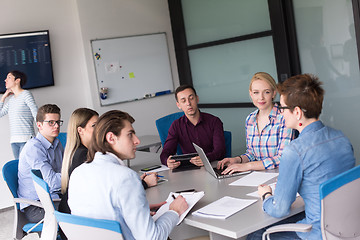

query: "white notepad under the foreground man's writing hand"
xmin=153 ymin=192 xmax=205 ymax=225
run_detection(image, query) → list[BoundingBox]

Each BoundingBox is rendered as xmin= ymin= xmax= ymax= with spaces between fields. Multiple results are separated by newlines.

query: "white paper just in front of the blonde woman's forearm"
xmin=229 ymin=172 xmax=279 ymax=187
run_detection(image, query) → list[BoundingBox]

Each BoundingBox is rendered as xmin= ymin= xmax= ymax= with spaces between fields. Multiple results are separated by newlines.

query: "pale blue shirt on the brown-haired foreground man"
xmin=68 ymin=152 xmax=179 ymax=240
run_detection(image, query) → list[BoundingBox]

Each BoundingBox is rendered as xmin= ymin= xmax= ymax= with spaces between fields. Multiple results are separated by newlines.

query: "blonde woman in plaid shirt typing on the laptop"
xmin=217 ymin=72 xmax=293 ymax=174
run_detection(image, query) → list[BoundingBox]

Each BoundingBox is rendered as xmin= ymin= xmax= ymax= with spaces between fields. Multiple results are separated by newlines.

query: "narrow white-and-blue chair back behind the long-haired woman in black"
xmin=31 ymin=169 xmax=58 ymax=240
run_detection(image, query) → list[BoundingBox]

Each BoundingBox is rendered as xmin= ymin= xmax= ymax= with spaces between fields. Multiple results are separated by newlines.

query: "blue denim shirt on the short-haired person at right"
xmin=263 ymin=121 xmax=355 ymax=239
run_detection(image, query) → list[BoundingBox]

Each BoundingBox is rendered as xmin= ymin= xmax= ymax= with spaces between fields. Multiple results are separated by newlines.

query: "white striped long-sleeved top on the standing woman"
xmin=0 ymin=90 xmax=37 ymax=143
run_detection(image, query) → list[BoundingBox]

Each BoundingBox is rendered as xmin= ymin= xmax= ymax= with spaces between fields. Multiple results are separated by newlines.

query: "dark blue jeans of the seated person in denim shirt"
xmin=246 ymin=212 xmax=305 ymax=240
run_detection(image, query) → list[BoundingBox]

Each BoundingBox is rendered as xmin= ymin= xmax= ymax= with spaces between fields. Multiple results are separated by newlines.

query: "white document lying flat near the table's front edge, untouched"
xmin=192 ymin=196 xmax=257 ymax=219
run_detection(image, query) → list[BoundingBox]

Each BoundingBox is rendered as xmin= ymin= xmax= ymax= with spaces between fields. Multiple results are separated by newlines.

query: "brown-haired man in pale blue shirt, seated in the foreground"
xmin=68 ymin=110 xmax=188 ymax=240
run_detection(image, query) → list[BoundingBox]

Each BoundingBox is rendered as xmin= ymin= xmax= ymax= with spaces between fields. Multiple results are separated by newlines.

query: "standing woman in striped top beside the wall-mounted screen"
xmin=0 ymin=70 xmax=37 ymax=159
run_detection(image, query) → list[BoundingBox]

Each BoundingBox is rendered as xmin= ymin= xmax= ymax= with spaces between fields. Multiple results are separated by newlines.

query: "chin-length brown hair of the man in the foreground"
xmin=86 ymin=110 xmax=135 ymax=163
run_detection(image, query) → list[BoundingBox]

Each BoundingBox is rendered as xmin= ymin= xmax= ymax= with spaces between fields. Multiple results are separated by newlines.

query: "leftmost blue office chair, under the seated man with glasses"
xmin=2 ymin=160 xmax=43 ymax=239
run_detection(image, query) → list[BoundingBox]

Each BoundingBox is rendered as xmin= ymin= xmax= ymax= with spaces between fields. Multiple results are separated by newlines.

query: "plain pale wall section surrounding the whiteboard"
xmin=76 ymin=0 xmax=179 ymax=131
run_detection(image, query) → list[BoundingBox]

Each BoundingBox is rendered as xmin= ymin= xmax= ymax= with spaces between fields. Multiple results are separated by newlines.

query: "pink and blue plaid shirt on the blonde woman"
xmin=244 ymin=104 xmax=294 ymax=169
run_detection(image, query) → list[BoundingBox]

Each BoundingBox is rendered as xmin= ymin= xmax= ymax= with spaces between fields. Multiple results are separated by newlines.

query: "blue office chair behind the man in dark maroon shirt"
xmin=155 ymin=112 xmax=232 ymax=157
